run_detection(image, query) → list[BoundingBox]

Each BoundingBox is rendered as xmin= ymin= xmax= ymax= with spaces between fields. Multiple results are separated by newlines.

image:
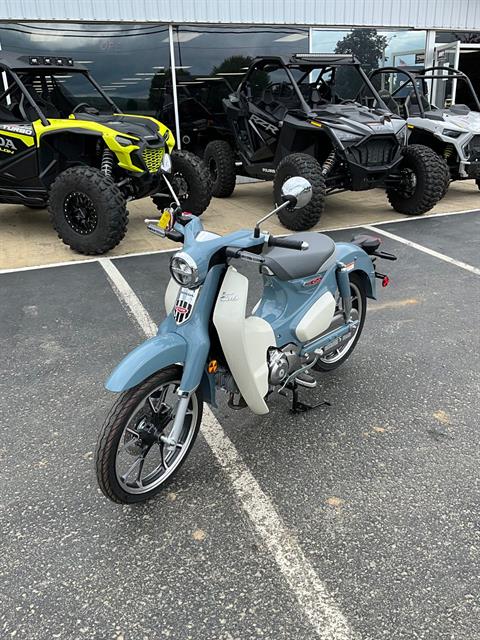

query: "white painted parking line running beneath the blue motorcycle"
xmin=99 ymin=258 xmax=355 ymax=640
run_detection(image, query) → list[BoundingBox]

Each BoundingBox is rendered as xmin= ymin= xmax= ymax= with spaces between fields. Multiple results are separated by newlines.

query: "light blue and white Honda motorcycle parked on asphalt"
xmin=96 ymin=177 xmax=395 ymax=503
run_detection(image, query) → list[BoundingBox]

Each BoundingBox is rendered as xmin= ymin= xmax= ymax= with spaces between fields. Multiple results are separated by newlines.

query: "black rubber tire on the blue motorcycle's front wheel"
xmin=95 ymin=366 xmax=203 ymax=504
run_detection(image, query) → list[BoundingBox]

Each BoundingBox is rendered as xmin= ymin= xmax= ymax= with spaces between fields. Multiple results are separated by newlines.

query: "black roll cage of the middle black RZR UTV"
xmin=237 ymin=53 xmax=390 ymax=116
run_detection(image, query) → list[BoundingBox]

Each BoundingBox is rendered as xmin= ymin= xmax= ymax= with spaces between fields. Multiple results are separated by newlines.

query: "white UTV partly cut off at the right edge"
xmin=370 ymin=67 xmax=480 ymax=195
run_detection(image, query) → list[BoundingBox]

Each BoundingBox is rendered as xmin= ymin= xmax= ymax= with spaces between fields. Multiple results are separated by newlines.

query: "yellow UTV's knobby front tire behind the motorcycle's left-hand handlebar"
xmin=152 ymin=151 xmax=212 ymax=216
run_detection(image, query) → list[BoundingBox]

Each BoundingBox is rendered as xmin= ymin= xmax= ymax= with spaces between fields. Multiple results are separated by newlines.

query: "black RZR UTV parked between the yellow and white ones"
xmin=204 ymin=54 xmax=448 ymax=231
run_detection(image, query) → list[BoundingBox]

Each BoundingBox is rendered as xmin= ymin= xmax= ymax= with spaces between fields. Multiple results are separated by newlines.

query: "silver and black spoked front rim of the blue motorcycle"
xmin=115 ymin=380 xmax=199 ymax=494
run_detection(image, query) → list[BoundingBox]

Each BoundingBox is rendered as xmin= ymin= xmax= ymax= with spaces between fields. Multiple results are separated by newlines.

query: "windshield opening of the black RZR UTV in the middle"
xmin=297 ymin=65 xmax=385 ymax=109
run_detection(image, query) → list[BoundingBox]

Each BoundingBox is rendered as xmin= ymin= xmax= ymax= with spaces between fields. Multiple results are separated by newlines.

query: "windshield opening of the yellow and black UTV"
xmin=14 ymin=69 xmax=113 ymax=120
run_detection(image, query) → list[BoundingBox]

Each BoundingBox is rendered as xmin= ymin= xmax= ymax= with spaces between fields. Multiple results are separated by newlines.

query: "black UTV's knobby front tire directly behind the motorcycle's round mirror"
xmin=273 ymin=153 xmax=326 ymax=231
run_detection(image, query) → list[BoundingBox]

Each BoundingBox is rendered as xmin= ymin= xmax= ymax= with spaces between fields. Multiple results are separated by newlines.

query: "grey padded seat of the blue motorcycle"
xmin=262 ymin=232 xmax=335 ymax=280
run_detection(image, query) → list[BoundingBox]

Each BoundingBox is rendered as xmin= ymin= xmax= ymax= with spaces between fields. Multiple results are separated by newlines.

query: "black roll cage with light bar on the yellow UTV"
xmin=0 ymin=52 xmax=122 ymax=126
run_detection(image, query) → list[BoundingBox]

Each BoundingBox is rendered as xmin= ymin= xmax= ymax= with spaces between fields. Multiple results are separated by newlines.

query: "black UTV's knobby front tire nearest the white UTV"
xmin=387 ymin=144 xmax=449 ymax=216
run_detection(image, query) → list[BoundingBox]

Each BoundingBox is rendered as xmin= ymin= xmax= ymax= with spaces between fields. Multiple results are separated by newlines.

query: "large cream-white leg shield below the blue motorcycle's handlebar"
xmin=213 ymin=267 xmax=276 ymax=415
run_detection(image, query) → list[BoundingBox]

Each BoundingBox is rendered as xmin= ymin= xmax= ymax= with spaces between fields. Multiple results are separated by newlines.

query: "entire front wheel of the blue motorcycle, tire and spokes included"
xmin=95 ymin=366 xmax=203 ymax=504
